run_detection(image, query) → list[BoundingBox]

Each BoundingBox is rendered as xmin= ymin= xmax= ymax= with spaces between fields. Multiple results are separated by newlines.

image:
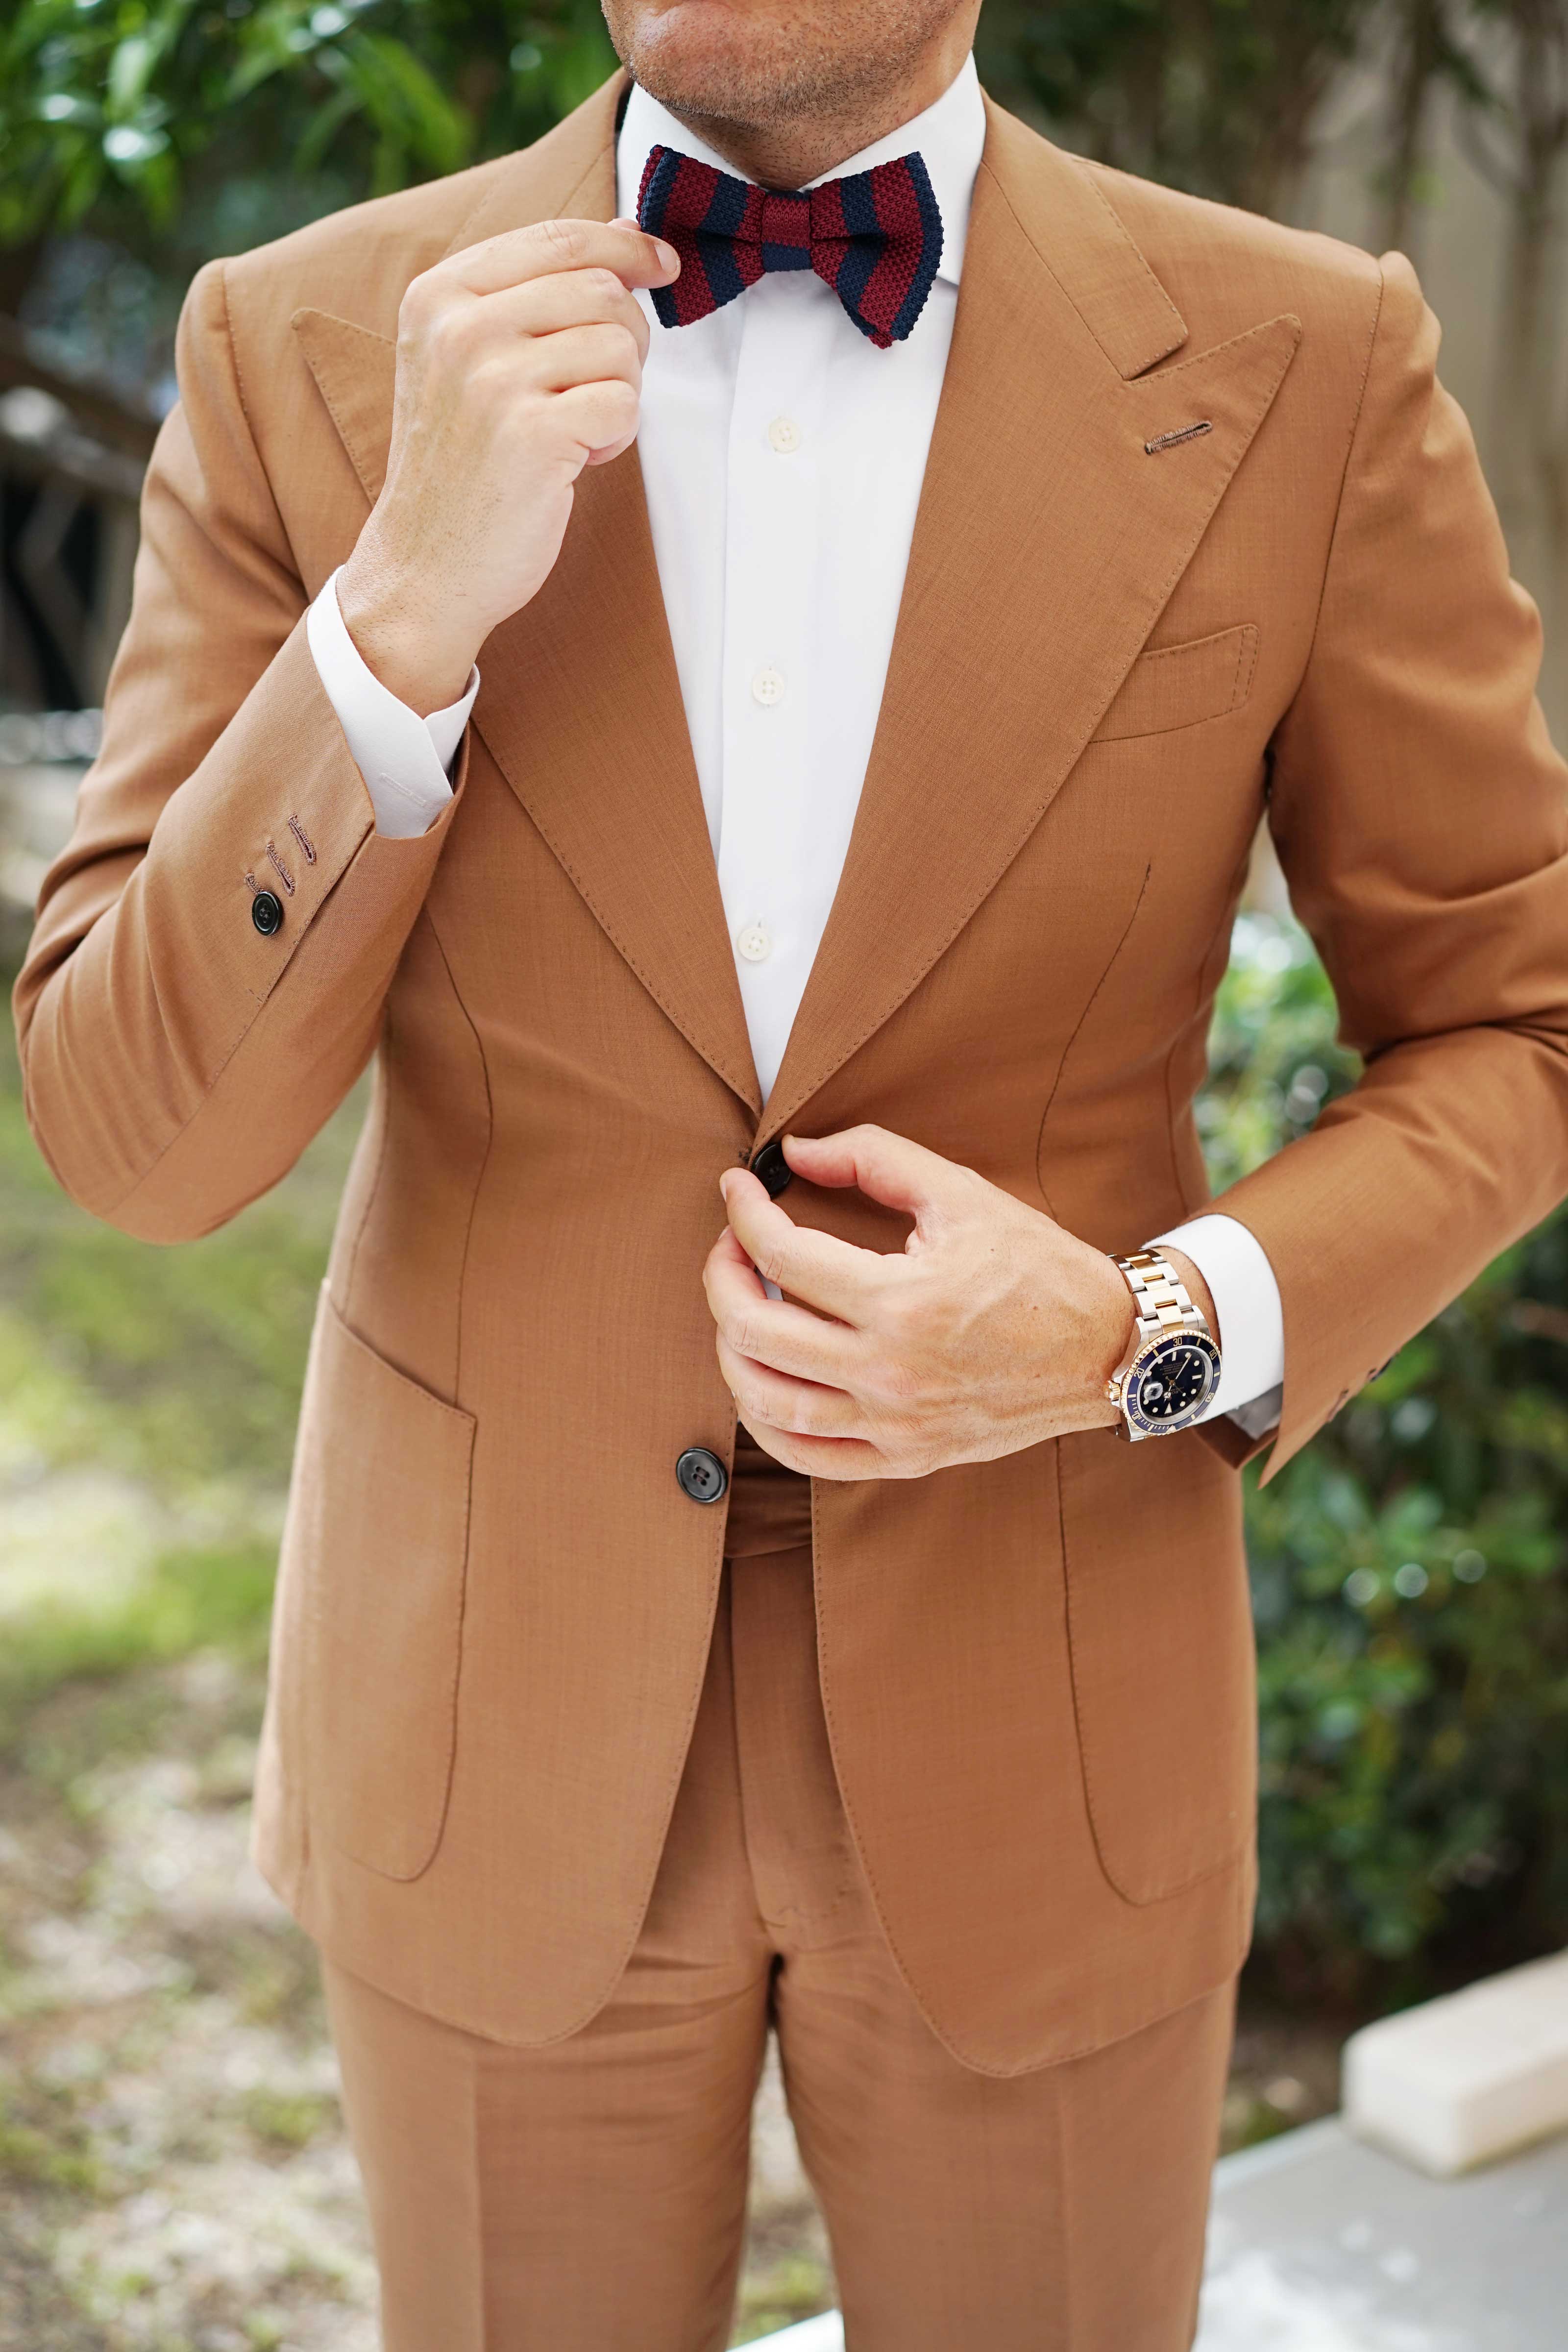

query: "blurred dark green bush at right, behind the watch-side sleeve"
xmin=1199 ymin=917 xmax=1568 ymax=2004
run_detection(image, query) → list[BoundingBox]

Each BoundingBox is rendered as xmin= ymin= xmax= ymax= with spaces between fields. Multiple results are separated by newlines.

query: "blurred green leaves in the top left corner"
xmin=0 ymin=0 xmax=613 ymax=268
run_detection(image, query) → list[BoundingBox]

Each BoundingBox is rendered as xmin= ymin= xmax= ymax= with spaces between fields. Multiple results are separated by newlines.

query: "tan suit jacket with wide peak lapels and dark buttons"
xmin=19 ymin=85 xmax=1568 ymax=2072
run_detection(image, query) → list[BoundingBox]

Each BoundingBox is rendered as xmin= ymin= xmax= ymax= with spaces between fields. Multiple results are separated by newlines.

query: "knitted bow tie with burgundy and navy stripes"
xmin=637 ymin=146 xmax=943 ymax=350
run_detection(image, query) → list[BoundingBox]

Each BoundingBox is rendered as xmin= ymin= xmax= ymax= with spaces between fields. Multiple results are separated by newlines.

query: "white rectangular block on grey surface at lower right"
xmin=1345 ymin=1952 xmax=1568 ymax=2178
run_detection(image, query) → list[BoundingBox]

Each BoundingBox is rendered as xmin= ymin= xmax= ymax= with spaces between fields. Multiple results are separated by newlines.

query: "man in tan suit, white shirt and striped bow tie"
xmin=19 ymin=0 xmax=1568 ymax=2352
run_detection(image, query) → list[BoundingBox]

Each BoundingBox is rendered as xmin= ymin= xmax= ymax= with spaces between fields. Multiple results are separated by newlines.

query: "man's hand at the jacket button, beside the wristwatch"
xmin=703 ymin=1127 xmax=1161 ymax=1479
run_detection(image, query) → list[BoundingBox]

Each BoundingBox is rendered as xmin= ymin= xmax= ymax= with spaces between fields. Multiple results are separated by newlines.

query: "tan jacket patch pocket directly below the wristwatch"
xmin=1060 ymin=1432 xmax=1258 ymax=1903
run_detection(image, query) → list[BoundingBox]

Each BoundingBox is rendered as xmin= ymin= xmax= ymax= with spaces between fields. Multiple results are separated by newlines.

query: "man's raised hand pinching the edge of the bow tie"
xmin=339 ymin=221 xmax=680 ymax=717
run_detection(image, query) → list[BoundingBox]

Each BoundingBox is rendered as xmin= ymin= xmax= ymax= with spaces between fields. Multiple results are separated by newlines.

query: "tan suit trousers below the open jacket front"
xmin=327 ymin=1550 xmax=1232 ymax=2352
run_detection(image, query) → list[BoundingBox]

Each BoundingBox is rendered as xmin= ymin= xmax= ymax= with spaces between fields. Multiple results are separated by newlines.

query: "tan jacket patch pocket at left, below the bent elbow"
xmin=285 ymin=1284 xmax=475 ymax=1879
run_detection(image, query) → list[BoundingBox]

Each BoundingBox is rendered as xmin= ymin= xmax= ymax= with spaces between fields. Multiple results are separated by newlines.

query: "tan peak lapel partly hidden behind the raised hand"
xmin=294 ymin=77 xmax=761 ymax=1112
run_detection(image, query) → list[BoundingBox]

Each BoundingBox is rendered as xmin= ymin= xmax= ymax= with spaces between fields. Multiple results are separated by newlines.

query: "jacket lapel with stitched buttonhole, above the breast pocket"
xmin=766 ymin=108 xmax=1300 ymax=1131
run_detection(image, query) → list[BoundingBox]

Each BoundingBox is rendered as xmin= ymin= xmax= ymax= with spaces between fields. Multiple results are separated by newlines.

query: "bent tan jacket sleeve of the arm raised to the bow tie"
xmin=17 ymin=264 xmax=463 ymax=1242
